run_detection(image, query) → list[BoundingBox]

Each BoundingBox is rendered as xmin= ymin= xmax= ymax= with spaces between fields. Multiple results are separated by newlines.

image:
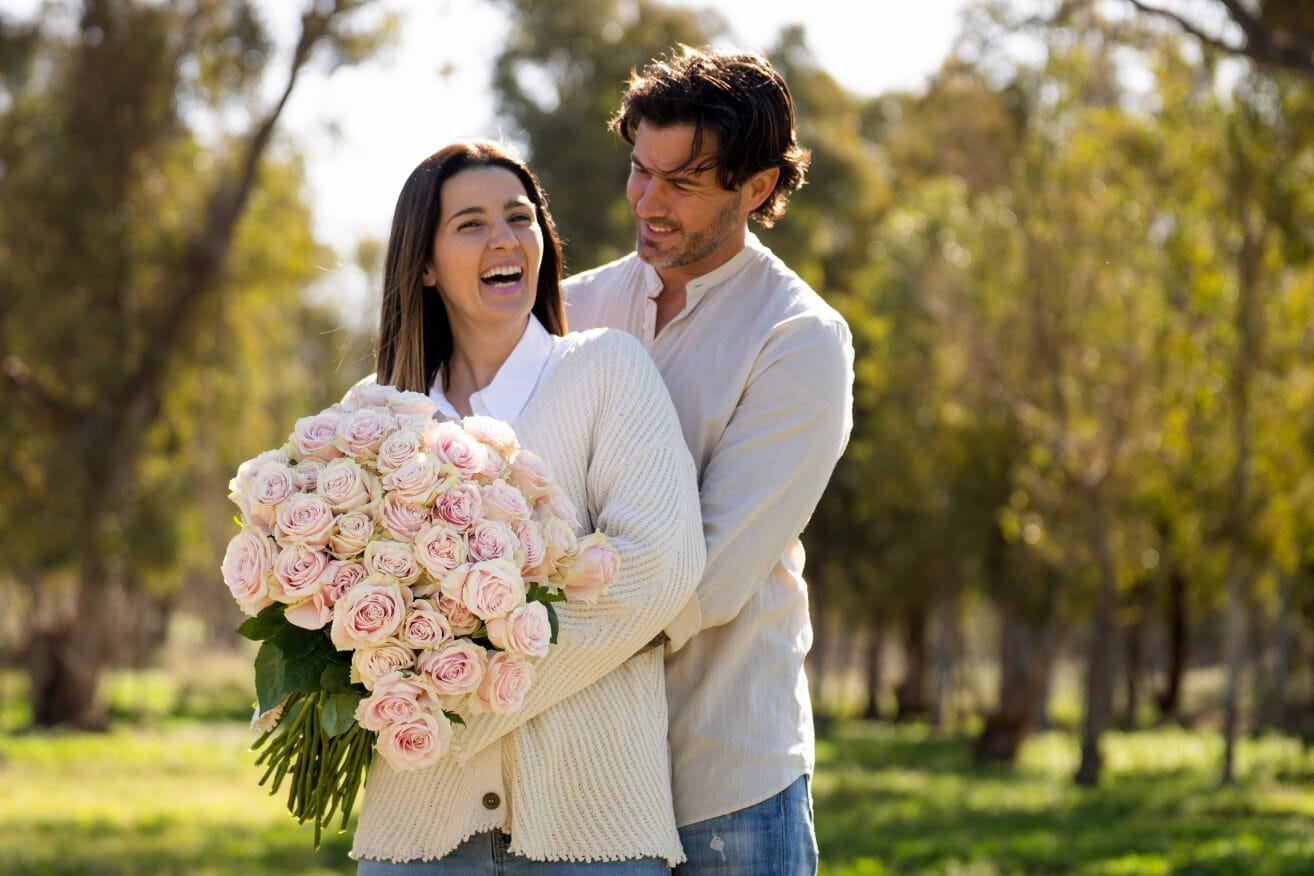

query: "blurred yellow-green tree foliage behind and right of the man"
xmin=495 ymin=0 xmax=1314 ymax=775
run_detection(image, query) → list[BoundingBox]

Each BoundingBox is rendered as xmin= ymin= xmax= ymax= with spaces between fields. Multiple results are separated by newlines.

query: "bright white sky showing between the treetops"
xmin=279 ymin=0 xmax=966 ymax=268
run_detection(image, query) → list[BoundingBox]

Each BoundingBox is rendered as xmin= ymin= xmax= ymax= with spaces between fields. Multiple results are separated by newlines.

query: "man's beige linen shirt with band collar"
xmin=566 ymin=234 xmax=853 ymax=826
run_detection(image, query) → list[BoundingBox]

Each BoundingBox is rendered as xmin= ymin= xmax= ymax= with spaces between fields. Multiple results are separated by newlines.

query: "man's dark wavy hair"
xmin=610 ymin=46 xmax=812 ymax=229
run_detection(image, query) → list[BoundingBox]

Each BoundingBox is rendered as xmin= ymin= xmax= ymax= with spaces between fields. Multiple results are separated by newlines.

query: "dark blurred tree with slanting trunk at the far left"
xmin=0 ymin=0 xmax=386 ymax=728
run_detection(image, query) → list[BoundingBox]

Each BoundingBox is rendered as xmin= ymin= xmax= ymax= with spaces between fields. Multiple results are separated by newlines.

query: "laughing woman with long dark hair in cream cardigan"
xmin=352 ymin=141 xmax=704 ymax=876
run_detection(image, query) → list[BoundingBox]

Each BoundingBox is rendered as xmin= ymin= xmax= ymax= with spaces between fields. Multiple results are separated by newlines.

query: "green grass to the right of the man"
xmin=815 ymin=724 xmax=1314 ymax=876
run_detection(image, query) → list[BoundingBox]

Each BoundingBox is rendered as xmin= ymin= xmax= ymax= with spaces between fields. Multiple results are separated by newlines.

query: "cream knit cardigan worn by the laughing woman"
xmin=351 ymin=330 xmax=704 ymax=865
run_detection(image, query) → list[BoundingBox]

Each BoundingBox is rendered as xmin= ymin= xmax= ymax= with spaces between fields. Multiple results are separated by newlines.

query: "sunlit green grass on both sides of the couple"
xmin=0 ymin=703 xmax=1314 ymax=876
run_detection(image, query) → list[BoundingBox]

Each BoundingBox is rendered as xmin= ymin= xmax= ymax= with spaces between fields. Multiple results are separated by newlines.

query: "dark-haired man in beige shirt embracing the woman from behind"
xmin=566 ymin=47 xmax=853 ymax=876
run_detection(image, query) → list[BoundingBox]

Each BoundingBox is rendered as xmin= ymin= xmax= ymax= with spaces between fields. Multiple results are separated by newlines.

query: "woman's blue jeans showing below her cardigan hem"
xmin=356 ymin=830 xmax=670 ymax=876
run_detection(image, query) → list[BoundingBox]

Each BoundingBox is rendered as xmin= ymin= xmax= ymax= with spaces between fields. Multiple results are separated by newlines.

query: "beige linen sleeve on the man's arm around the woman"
xmin=666 ymin=315 xmax=853 ymax=651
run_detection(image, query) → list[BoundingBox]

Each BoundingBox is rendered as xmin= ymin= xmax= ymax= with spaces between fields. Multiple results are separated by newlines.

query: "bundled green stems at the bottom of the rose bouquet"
xmin=252 ymin=691 xmax=374 ymax=848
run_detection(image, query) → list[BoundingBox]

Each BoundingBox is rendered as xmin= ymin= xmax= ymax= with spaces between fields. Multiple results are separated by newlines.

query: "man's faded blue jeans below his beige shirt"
xmin=674 ymin=776 xmax=817 ymax=876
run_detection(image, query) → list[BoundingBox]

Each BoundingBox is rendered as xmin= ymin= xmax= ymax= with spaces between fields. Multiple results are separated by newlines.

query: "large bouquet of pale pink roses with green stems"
xmin=222 ymin=383 xmax=618 ymax=847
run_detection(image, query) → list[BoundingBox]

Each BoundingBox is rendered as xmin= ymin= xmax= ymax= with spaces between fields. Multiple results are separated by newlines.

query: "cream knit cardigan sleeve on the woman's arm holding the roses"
xmin=455 ymin=332 xmax=704 ymax=759
